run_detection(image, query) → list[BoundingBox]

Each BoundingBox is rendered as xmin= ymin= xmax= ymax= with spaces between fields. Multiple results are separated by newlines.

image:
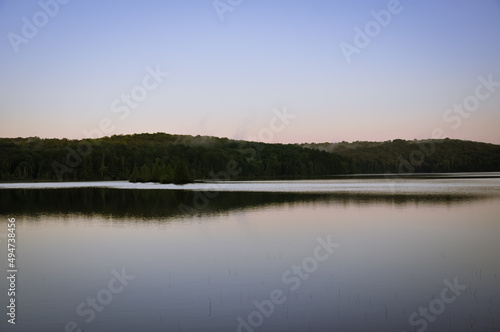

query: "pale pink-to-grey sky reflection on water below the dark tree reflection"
xmin=0 ymin=183 xmax=500 ymax=331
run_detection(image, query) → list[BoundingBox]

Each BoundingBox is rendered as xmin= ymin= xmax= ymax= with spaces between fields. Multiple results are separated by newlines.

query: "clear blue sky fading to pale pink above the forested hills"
xmin=0 ymin=0 xmax=500 ymax=144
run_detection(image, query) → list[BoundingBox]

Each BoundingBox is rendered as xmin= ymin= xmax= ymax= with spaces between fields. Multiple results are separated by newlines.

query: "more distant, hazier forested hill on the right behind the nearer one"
xmin=301 ymin=138 xmax=500 ymax=174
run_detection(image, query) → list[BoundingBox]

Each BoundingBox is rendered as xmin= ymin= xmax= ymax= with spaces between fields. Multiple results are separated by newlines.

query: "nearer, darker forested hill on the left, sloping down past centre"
xmin=0 ymin=133 xmax=349 ymax=183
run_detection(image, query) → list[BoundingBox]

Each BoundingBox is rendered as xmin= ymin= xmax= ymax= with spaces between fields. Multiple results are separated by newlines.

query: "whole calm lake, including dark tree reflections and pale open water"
xmin=0 ymin=173 xmax=500 ymax=332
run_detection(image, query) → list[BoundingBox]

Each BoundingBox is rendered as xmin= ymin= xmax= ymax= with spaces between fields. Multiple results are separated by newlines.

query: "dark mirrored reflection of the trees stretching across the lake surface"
xmin=0 ymin=188 xmax=490 ymax=218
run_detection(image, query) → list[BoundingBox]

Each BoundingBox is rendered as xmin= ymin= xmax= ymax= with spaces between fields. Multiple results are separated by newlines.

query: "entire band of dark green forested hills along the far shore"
xmin=0 ymin=133 xmax=500 ymax=183
